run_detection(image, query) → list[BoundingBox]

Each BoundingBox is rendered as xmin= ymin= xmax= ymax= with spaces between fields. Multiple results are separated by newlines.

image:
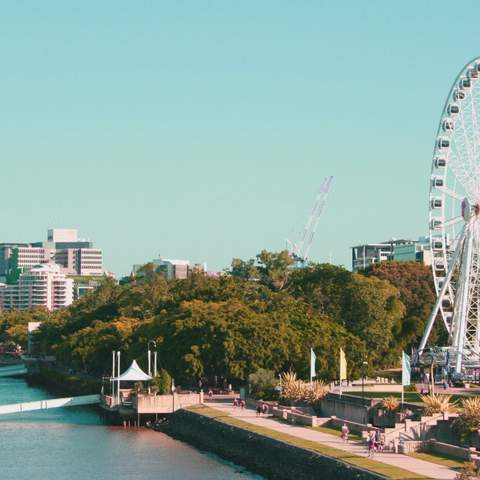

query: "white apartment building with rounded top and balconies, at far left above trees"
xmin=0 ymin=264 xmax=73 ymax=310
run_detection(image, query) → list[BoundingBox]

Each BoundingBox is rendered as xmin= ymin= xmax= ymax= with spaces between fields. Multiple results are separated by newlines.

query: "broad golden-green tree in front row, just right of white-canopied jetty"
xmin=151 ymin=300 xmax=288 ymax=380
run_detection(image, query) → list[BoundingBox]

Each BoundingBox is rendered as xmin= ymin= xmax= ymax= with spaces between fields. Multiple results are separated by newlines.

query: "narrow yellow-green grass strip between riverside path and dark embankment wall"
xmin=186 ymin=405 xmax=429 ymax=480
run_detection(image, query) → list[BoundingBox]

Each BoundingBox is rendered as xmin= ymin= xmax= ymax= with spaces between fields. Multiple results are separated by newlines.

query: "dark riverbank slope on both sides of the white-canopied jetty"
xmin=28 ymin=366 xmax=388 ymax=480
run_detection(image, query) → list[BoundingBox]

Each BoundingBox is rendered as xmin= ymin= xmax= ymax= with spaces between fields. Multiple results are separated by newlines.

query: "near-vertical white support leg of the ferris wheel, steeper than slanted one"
xmin=453 ymin=232 xmax=473 ymax=373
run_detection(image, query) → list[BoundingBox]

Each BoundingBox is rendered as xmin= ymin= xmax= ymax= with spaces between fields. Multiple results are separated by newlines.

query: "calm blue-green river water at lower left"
xmin=0 ymin=378 xmax=262 ymax=480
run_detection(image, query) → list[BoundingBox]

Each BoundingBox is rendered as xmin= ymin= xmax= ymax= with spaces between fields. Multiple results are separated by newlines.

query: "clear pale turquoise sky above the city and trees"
xmin=0 ymin=0 xmax=480 ymax=274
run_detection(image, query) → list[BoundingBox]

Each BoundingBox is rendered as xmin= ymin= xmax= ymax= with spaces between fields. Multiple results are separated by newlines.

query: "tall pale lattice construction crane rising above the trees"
xmin=287 ymin=177 xmax=333 ymax=268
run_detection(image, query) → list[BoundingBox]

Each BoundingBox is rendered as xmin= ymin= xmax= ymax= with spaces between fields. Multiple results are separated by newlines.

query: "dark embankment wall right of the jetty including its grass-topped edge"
xmin=164 ymin=407 xmax=412 ymax=480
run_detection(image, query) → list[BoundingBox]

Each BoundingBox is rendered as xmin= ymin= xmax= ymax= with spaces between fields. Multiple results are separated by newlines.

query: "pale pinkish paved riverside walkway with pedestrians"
xmin=205 ymin=401 xmax=457 ymax=480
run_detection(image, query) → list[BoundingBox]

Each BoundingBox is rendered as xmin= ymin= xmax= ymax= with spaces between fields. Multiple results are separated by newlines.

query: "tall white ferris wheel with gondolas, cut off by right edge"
xmin=419 ymin=57 xmax=480 ymax=375
